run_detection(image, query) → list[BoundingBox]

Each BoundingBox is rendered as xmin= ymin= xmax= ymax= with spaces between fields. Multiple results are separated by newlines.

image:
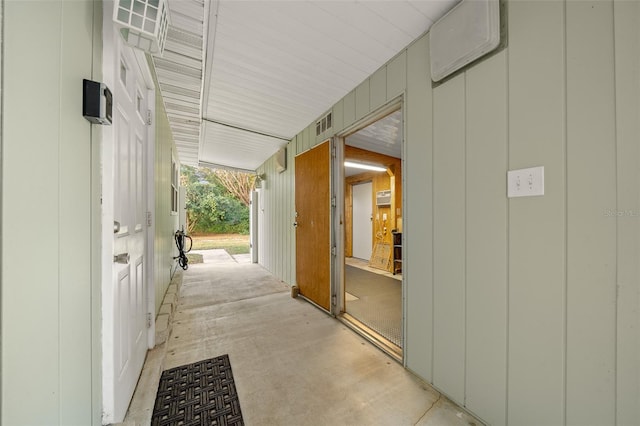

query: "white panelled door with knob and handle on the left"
xmin=113 ymin=42 xmax=148 ymax=419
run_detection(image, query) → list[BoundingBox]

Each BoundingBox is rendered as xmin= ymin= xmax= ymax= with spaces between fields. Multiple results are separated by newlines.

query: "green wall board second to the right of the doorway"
xmin=432 ymin=74 xmax=466 ymax=401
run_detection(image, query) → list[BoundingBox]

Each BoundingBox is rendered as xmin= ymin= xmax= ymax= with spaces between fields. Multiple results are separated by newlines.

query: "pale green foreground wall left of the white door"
xmin=0 ymin=0 xmax=102 ymax=425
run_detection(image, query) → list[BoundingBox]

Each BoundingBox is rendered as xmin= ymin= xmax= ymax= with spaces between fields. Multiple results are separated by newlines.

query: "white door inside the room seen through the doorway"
xmin=351 ymin=182 xmax=373 ymax=260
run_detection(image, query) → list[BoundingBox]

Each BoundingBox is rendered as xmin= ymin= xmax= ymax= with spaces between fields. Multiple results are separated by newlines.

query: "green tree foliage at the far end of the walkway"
xmin=181 ymin=166 xmax=249 ymax=234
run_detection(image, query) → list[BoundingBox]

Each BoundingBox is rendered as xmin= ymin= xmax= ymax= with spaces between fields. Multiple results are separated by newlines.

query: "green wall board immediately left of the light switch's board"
xmin=462 ymin=52 xmax=508 ymax=424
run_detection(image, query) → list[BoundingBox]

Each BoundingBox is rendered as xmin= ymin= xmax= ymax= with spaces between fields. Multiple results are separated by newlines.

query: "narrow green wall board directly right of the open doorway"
xmin=402 ymin=37 xmax=434 ymax=382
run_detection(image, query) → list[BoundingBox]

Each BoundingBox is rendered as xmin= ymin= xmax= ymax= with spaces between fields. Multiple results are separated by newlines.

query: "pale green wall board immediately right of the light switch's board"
xmin=564 ymin=2 xmax=617 ymax=425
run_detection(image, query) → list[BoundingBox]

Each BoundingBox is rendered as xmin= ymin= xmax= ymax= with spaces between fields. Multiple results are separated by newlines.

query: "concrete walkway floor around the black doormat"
xmin=124 ymin=250 xmax=482 ymax=426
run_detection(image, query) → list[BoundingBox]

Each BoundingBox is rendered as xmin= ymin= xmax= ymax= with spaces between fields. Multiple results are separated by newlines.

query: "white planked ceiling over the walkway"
xmin=156 ymin=0 xmax=458 ymax=170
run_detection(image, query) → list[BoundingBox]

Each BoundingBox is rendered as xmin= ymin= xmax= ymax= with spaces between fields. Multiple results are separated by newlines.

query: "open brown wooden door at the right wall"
xmin=295 ymin=141 xmax=331 ymax=310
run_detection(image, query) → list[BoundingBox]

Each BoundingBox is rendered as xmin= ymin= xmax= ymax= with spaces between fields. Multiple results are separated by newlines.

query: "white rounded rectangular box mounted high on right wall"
xmin=429 ymin=0 xmax=500 ymax=81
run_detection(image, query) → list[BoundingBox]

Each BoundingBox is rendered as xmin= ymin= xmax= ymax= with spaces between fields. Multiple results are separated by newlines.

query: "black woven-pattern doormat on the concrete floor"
xmin=151 ymin=355 xmax=244 ymax=426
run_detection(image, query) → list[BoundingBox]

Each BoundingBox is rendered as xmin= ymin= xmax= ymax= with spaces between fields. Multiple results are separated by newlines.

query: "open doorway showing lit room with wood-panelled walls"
xmin=339 ymin=106 xmax=403 ymax=360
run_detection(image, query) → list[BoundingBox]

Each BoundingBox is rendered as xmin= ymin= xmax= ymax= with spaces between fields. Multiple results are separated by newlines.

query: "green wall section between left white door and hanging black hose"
xmin=149 ymin=61 xmax=180 ymax=315
